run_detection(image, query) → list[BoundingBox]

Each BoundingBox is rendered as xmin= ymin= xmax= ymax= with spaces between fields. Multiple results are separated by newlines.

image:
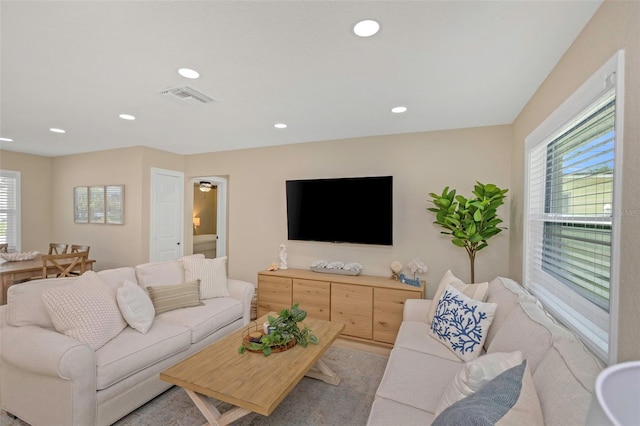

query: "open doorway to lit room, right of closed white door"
xmin=192 ymin=176 xmax=227 ymax=259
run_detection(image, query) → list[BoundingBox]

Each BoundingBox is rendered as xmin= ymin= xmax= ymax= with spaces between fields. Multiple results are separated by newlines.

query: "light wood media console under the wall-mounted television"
xmin=258 ymin=269 xmax=425 ymax=346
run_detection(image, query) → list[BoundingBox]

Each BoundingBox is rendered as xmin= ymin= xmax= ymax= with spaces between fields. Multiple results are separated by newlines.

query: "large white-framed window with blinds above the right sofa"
xmin=523 ymin=50 xmax=621 ymax=360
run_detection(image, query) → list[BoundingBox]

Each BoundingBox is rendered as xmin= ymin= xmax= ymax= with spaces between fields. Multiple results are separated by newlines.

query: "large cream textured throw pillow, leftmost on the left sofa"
xmin=42 ymin=271 xmax=127 ymax=350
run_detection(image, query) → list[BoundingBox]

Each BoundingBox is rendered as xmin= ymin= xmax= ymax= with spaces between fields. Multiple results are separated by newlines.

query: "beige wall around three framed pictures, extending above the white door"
xmin=45 ymin=146 xmax=184 ymax=270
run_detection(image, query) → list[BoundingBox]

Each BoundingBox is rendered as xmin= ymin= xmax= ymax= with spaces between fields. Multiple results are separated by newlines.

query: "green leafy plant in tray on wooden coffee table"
xmin=238 ymin=303 xmax=318 ymax=356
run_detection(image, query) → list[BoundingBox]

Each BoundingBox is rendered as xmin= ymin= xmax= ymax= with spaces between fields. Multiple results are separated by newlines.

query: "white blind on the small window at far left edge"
xmin=0 ymin=170 xmax=20 ymax=251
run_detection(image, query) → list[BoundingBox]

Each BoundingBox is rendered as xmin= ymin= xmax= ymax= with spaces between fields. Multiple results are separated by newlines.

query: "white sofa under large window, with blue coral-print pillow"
xmin=368 ymin=278 xmax=603 ymax=426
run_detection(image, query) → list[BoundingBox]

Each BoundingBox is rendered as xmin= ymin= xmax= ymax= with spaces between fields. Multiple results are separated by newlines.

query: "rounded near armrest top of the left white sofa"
xmin=2 ymin=326 xmax=96 ymax=382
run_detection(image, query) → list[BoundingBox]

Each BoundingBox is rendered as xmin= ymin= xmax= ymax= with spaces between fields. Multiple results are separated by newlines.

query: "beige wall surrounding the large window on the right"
xmin=509 ymin=1 xmax=640 ymax=361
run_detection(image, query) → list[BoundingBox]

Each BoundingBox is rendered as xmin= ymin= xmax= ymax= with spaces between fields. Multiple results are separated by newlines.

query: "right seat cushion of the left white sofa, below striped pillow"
xmin=157 ymin=297 xmax=243 ymax=343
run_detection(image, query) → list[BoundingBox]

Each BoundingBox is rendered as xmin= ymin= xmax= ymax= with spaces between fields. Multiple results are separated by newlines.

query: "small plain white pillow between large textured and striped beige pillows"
xmin=116 ymin=280 xmax=156 ymax=333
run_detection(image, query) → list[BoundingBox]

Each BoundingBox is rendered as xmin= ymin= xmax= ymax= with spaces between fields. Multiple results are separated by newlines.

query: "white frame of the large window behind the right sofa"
xmin=522 ymin=50 xmax=624 ymax=364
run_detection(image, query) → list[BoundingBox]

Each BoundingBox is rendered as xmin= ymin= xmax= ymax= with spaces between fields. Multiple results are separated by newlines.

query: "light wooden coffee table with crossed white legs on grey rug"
xmin=160 ymin=313 xmax=344 ymax=425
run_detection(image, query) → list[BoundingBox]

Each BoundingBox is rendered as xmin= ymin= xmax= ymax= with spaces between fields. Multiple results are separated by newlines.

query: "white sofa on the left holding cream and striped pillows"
xmin=0 ymin=255 xmax=255 ymax=426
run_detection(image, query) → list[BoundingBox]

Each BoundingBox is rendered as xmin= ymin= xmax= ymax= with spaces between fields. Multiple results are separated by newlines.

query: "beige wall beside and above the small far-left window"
xmin=0 ymin=151 xmax=54 ymax=252
